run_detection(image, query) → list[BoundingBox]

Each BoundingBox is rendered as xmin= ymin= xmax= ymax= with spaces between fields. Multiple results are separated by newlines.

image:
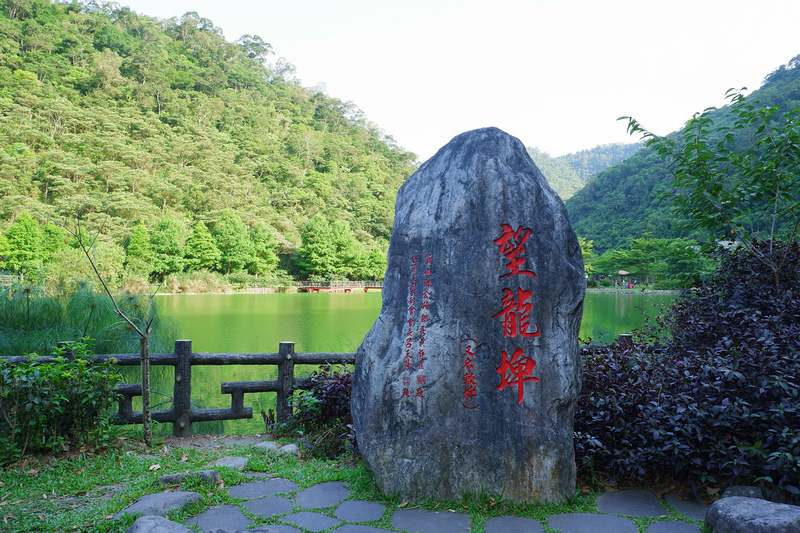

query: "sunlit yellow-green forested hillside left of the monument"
xmin=0 ymin=0 xmax=416 ymax=277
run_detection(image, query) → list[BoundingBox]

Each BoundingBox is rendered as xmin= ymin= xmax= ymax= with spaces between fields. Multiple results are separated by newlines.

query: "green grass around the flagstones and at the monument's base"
xmin=0 ymin=439 xmax=708 ymax=533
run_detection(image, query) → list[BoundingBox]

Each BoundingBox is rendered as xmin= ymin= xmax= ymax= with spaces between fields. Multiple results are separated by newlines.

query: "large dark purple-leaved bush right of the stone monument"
xmin=575 ymin=242 xmax=800 ymax=502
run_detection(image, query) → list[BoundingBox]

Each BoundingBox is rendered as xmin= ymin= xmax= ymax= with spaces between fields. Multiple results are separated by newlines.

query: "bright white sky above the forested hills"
xmin=111 ymin=0 xmax=800 ymax=161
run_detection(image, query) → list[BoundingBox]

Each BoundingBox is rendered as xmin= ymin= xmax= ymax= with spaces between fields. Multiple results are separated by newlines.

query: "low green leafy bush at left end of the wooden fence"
xmin=0 ymin=341 xmax=120 ymax=465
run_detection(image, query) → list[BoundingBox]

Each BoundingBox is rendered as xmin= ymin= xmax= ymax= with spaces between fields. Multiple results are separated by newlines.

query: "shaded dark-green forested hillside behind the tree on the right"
xmin=565 ymin=56 xmax=800 ymax=253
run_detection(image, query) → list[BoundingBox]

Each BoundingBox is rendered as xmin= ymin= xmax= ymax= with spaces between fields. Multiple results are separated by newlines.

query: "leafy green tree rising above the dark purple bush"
xmin=622 ymin=89 xmax=800 ymax=287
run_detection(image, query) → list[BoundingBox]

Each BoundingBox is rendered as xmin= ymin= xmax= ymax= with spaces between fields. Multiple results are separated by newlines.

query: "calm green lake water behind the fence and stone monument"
xmin=136 ymin=291 xmax=676 ymax=434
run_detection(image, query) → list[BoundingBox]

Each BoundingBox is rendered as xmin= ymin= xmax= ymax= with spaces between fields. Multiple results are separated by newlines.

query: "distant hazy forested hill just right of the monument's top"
xmin=528 ymin=143 xmax=642 ymax=200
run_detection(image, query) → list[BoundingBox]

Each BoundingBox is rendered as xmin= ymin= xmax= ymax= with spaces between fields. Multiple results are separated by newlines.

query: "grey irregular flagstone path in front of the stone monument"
xmin=178 ymin=478 xmax=707 ymax=533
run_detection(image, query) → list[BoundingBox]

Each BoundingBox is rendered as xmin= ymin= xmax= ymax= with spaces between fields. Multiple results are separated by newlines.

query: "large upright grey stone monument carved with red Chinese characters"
xmin=352 ymin=128 xmax=585 ymax=501
